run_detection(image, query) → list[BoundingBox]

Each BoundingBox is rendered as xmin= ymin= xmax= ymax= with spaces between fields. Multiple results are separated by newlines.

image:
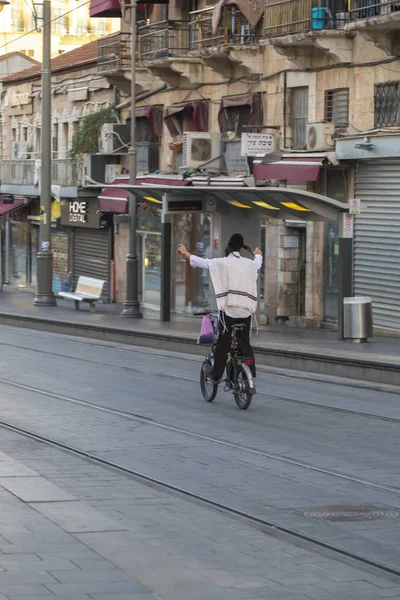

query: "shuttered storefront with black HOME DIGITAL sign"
xmin=60 ymin=198 xmax=113 ymax=302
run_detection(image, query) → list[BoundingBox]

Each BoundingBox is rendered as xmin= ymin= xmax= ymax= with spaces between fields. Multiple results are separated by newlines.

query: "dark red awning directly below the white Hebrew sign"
xmin=253 ymin=157 xmax=324 ymax=181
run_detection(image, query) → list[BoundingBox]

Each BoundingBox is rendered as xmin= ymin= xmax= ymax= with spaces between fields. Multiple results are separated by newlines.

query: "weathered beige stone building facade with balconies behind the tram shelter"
xmin=3 ymin=0 xmax=400 ymax=329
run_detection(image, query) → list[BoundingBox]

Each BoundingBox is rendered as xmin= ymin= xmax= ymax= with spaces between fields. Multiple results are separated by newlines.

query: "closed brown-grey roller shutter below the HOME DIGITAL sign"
xmin=73 ymin=228 xmax=111 ymax=301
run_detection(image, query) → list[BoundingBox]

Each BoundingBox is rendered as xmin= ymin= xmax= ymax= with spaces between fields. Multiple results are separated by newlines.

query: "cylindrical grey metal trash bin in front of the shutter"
xmin=343 ymin=296 xmax=373 ymax=342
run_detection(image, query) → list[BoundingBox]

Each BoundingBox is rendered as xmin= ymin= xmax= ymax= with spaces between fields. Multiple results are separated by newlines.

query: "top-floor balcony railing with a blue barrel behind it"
xmin=265 ymin=0 xmax=350 ymax=37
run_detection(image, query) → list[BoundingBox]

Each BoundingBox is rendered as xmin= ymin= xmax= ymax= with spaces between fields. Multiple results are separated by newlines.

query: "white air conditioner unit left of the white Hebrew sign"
xmin=182 ymin=131 xmax=221 ymax=169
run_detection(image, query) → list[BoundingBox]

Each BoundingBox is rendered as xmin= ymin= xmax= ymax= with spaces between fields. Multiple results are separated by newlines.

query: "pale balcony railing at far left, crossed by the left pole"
xmin=1 ymin=158 xmax=78 ymax=187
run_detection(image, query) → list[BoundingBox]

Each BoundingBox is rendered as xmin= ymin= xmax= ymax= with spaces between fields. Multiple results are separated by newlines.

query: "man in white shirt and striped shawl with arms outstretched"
xmin=178 ymin=233 xmax=262 ymax=390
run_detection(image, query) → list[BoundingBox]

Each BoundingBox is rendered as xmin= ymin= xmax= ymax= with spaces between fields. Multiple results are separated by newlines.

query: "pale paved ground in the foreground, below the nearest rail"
xmin=0 ymin=422 xmax=400 ymax=600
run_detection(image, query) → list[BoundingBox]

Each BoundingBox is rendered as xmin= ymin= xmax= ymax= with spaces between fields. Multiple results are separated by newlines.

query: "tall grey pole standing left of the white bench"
xmin=33 ymin=0 xmax=56 ymax=306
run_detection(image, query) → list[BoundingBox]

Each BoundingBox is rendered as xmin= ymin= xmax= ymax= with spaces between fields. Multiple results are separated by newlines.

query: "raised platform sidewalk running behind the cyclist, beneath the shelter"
xmin=0 ymin=291 xmax=400 ymax=385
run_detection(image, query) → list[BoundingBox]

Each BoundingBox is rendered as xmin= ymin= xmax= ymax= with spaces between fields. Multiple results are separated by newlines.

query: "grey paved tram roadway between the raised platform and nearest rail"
xmin=0 ymin=327 xmax=400 ymax=600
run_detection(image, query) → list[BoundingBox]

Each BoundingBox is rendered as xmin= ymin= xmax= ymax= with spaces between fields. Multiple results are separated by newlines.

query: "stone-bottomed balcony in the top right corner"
xmin=346 ymin=0 xmax=400 ymax=56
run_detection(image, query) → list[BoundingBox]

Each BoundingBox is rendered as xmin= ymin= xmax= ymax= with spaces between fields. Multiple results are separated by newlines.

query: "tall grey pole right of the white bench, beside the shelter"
xmin=121 ymin=0 xmax=142 ymax=319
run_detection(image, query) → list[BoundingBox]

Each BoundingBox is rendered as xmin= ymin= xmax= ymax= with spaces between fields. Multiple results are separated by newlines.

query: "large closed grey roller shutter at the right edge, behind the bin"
xmin=354 ymin=160 xmax=400 ymax=329
